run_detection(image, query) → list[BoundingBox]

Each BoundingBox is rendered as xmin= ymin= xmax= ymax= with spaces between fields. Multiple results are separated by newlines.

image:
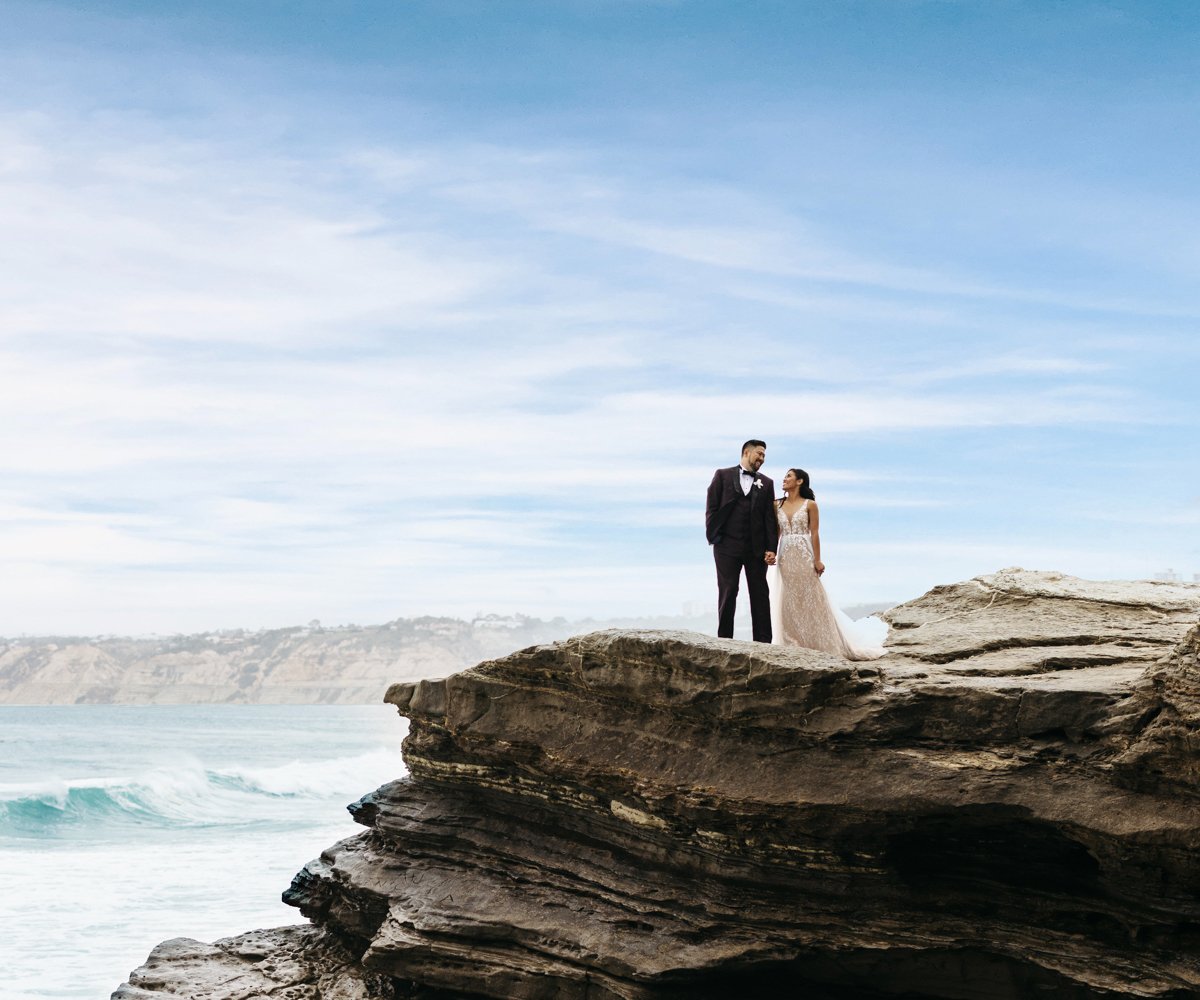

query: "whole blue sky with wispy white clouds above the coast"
xmin=0 ymin=0 xmax=1200 ymax=636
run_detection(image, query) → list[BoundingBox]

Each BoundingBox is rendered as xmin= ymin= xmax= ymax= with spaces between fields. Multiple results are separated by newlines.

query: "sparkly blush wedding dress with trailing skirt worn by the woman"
xmin=768 ymin=501 xmax=887 ymax=660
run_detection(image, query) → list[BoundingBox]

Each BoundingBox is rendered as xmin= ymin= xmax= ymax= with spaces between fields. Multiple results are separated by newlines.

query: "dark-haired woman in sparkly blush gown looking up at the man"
xmin=770 ymin=468 xmax=886 ymax=660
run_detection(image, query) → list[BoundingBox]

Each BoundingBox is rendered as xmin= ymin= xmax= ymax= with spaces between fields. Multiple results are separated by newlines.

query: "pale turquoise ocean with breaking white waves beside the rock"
xmin=0 ymin=705 xmax=407 ymax=1000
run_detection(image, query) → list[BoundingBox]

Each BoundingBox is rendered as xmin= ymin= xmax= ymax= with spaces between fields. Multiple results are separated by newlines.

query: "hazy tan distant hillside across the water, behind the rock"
xmin=0 ymin=607 xmax=878 ymax=705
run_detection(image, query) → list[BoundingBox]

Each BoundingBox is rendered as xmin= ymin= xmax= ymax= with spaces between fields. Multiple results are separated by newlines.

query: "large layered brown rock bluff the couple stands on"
xmin=113 ymin=569 xmax=1200 ymax=1000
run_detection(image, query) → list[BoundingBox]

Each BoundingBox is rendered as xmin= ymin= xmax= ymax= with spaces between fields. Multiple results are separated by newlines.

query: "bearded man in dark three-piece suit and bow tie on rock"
xmin=704 ymin=441 xmax=779 ymax=642
